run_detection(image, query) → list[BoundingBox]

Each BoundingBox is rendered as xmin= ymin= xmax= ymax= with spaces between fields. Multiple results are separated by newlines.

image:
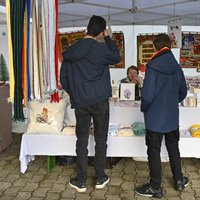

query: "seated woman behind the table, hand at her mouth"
xmin=120 ymin=65 xmax=140 ymax=100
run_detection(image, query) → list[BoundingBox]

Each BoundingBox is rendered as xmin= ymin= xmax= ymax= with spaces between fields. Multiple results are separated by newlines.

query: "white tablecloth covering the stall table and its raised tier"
xmin=20 ymin=106 xmax=200 ymax=173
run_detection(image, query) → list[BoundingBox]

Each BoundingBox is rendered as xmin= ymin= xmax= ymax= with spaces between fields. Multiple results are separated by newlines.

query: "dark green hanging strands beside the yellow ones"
xmin=10 ymin=0 xmax=26 ymax=121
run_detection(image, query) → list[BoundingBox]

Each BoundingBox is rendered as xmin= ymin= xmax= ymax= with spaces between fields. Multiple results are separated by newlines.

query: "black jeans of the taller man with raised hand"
xmin=75 ymin=100 xmax=109 ymax=183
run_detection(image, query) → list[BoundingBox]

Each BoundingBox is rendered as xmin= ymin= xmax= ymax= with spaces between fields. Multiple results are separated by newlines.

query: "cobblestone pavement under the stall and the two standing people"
xmin=0 ymin=133 xmax=200 ymax=200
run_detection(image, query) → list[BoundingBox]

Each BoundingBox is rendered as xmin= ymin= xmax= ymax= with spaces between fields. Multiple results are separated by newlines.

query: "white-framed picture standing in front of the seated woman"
xmin=120 ymin=83 xmax=135 ymax=100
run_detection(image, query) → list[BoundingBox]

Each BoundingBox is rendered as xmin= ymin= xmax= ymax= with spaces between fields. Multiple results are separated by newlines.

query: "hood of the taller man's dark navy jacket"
xmin=62 ymin=38 xmax=96 ymax=62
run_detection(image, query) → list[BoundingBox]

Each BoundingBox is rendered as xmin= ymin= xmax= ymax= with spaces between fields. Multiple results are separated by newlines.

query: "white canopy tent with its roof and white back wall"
xmin=0 ymin=0 xmax=200 ymax=83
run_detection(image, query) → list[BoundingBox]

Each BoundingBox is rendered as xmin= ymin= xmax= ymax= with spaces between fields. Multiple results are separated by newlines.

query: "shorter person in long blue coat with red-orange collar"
xmin=135 ymin=34 xmax=188 ymax=198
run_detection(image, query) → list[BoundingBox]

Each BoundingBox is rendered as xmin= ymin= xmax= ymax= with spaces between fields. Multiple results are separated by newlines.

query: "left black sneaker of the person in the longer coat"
xmin=135 ymin=183 xmax=163 ymax=199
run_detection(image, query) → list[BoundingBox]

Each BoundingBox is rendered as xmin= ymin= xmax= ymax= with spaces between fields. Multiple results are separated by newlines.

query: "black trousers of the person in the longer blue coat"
xmin=146 ymin=129 xmax=183 ymax=189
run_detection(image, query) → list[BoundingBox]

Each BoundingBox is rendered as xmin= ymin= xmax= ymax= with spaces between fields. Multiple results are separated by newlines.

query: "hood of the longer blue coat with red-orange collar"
xmin=147 ymin=52 xmax=179 ymax=75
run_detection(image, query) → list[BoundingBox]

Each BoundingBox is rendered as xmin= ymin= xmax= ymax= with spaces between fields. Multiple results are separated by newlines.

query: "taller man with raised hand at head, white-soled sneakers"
xmin=60 ymin=15 xmax=121 ymax=192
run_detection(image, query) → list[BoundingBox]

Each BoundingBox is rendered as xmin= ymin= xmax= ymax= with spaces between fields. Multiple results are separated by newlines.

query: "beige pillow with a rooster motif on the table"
xmin=26 ymin=99 xmax=67 ymax=134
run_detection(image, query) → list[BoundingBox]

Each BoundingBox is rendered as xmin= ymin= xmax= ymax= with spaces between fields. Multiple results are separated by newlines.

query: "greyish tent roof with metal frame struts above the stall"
xmin=0 ymin=0 xmax=200 ymax=28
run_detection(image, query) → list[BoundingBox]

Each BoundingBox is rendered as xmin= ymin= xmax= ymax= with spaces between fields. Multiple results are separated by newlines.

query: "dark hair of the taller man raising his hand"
xmin=87 ymin=15 xmax=106 ymax=37
